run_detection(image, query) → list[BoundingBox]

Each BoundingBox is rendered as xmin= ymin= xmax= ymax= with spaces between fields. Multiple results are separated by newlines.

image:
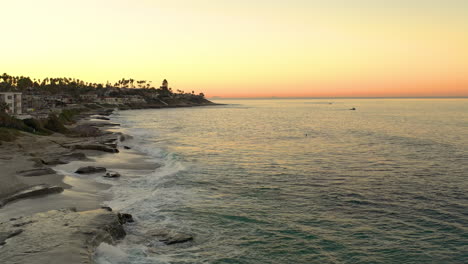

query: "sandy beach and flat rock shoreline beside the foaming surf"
xmin=0 ymin=103 xmax=218 ymax=263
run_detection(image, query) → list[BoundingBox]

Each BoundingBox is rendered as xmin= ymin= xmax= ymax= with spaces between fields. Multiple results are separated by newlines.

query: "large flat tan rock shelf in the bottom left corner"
xmin=0 ymin=209 xmax=126 ymax=264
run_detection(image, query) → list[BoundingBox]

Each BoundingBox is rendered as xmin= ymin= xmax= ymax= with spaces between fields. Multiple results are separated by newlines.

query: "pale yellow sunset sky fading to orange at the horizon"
xmin=0 ymin=0 xmax=468 ymax=97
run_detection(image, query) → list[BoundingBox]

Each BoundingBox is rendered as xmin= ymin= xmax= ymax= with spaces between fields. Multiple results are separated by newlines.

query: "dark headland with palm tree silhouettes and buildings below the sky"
xmin=0 ymin=73 xmax=212 ymax=119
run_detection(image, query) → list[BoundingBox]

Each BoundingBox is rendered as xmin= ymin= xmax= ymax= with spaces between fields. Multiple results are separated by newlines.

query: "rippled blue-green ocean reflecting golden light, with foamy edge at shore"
xmin=96 ymin=99 xmax=468 ymax=264
